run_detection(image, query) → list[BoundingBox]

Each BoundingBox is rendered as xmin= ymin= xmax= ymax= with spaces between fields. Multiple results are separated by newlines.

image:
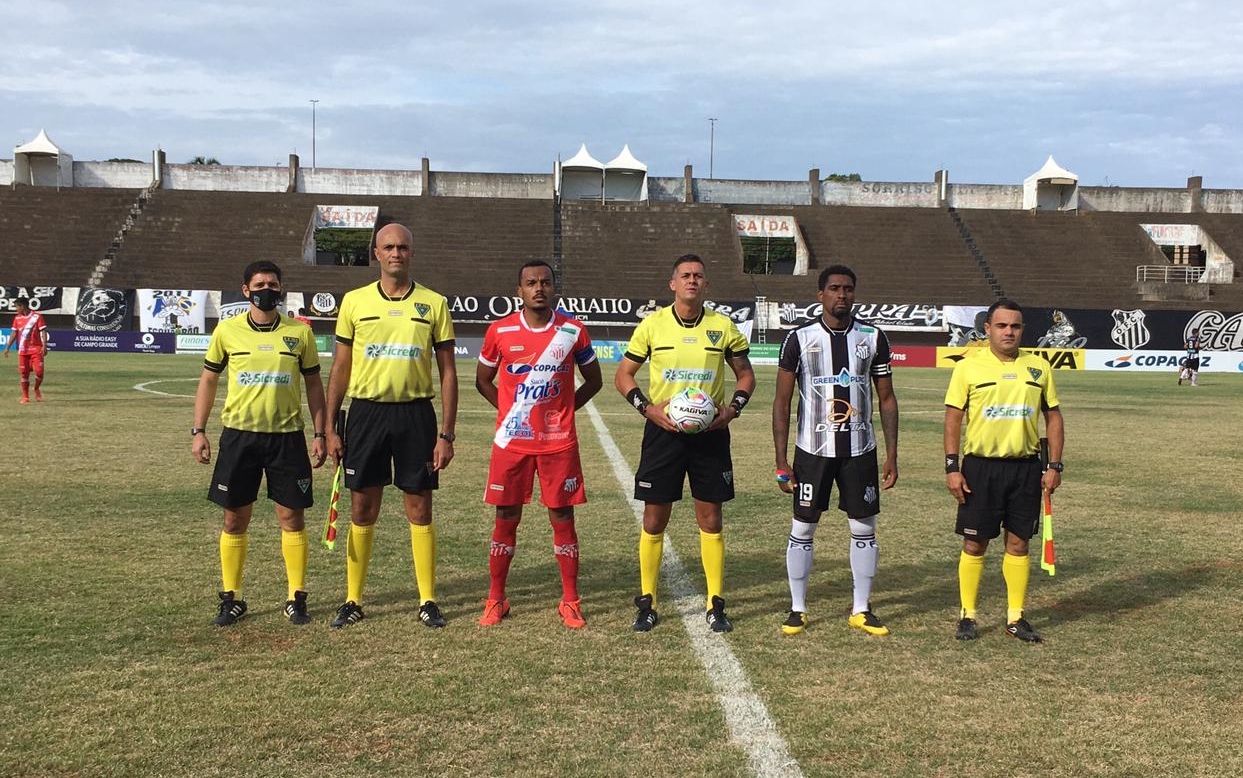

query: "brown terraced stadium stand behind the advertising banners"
xmin=0 ymin=181 xmax=1243 ymax=311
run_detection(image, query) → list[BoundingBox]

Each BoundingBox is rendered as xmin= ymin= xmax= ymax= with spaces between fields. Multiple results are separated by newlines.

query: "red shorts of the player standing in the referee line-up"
xmin=484 ymin=445 xmax=587 ymax=508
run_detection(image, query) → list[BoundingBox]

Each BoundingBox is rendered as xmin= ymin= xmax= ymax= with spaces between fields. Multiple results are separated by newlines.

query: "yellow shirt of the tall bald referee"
xmin=337 ymin=281 xmax=454 ymax=403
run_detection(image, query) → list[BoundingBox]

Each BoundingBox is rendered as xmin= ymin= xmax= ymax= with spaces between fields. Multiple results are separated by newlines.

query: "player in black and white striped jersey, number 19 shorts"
xmin=773 ymin=265 xmax=897 ymax=635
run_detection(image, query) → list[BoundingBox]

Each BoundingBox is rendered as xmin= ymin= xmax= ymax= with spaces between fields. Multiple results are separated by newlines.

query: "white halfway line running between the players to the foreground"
xmin=587 ymin=403 xmax=803 ymax=778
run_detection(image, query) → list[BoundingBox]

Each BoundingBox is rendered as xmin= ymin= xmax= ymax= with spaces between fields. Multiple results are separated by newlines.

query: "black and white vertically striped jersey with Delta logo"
xmin=777 ymin=317 xmax=892 ymax=457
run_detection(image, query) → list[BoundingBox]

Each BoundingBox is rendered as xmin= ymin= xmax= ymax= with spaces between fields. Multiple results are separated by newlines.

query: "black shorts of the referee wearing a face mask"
xmin=208 ymin=428 xmax=314 ymax=511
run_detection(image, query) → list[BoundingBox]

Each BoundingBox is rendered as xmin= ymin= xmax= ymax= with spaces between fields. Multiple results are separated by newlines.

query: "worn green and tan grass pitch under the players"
xmin=0 ymin=354 xmax=1243 ymax=778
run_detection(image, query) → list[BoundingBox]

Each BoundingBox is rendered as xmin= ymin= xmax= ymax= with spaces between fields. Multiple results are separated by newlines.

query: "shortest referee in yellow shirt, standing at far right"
xmin=945 ymin=293 xmax=1065 ymax=643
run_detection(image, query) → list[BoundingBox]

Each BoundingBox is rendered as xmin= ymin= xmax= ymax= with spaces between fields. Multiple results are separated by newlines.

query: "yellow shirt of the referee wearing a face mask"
xmin=203 ymin=313 xmax=319 ymax=432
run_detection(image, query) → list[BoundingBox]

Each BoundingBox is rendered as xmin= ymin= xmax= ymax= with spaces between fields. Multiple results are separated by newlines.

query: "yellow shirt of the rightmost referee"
xmin=945 ymin=348 xmax=1059 ymax=459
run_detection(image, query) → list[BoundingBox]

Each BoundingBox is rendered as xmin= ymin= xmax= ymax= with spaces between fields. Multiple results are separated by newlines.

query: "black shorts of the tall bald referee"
xmin=343 ymin=400 xmax=440 ymax=495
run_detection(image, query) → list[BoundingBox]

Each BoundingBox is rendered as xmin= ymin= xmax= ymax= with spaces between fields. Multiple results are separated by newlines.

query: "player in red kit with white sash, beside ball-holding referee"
xmin=475 ymin=261 xmax=603 ymax=629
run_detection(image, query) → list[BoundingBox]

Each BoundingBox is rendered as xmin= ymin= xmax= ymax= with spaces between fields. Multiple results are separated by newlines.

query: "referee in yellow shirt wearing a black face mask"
xmin=190 ymin=261 xmax=328 ymax=626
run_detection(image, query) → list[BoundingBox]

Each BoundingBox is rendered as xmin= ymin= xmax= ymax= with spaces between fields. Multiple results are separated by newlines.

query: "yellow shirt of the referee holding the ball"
xmin=625 ymin=306 xmax=750 ymax=405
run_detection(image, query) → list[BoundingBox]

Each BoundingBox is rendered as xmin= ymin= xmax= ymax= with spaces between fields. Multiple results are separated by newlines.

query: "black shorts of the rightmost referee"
xmin=955 ymin=455 xmax=1040 ymax=541
